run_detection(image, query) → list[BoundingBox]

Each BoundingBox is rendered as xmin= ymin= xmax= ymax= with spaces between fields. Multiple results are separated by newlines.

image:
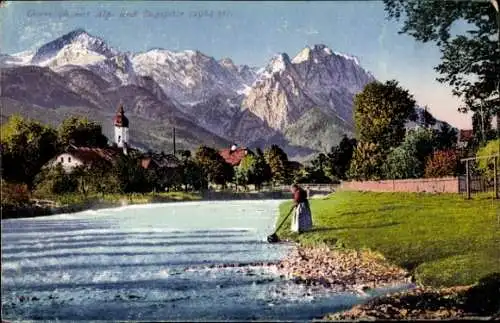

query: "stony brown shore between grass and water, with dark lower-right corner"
xmin=268 ymin=247 xmax=500 ymax=320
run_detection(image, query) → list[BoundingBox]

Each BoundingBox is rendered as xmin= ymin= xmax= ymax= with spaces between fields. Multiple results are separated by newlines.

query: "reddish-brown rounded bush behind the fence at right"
xmin=424 ymin=149 xmax=460 ymax=178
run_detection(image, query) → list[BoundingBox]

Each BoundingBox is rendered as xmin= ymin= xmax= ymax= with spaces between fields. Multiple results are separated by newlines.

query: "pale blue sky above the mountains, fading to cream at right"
xmin=0 ymin=1 xmax=471 ymax=128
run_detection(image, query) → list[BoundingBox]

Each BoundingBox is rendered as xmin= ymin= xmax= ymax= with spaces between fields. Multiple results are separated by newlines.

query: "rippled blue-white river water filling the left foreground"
xmin=2 ymin=200 xmax=410 ymax=321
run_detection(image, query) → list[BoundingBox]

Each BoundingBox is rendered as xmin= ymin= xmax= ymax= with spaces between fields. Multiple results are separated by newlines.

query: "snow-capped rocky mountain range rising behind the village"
xmin=0 ymin=29 xmax=446 ymax=157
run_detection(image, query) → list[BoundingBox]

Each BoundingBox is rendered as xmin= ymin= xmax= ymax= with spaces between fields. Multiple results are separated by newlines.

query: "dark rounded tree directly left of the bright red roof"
xmin=195 ymin=146 xmax=234 ymax=186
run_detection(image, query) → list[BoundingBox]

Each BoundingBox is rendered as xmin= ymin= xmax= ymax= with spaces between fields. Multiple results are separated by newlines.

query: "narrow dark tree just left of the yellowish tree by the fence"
xmin=325 ymin=135 xmax=356 ymax=181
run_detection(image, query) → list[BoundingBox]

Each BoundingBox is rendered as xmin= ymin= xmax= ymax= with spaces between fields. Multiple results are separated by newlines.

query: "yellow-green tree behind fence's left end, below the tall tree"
xmin=348 ymin=141 xmax=386 ymax=180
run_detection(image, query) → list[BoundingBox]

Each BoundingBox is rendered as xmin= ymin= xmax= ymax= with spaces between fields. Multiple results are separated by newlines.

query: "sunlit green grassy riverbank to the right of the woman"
xmin=279 ymin=192 xmax=500 ymax=287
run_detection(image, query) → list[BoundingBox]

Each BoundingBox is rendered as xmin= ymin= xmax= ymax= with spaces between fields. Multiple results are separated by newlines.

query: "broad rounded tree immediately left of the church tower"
xmin=57 ymin=116 xmax=108 ymax=147
